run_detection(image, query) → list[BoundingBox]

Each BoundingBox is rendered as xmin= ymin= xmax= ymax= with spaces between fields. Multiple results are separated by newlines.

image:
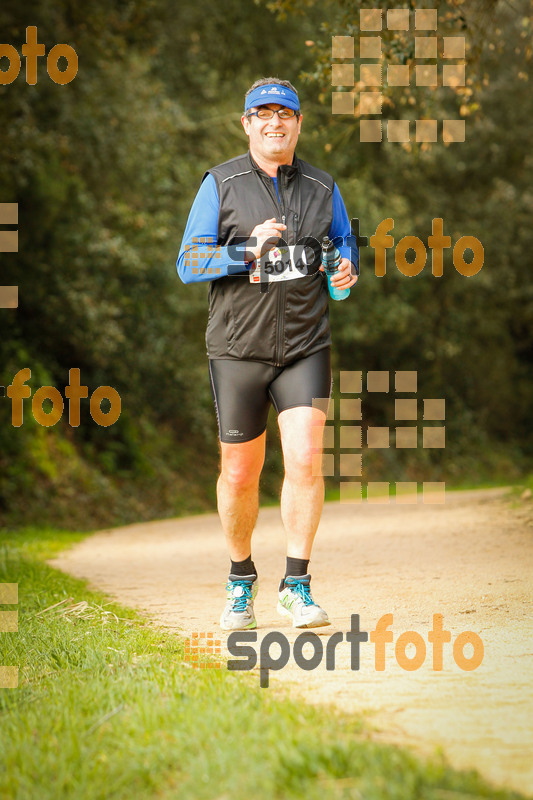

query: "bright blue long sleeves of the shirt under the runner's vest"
xmin=177 ymin=174 xmax=358 ymax=283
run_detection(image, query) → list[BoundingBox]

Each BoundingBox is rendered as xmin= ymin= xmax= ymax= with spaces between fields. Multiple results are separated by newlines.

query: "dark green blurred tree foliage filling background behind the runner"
xmin=0 ymin=0 xmax=533 ymax=527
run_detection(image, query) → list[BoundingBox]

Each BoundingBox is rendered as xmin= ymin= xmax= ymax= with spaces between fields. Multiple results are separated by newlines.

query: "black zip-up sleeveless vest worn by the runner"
xmin=204 ymin=153 xmax=334 ymax=366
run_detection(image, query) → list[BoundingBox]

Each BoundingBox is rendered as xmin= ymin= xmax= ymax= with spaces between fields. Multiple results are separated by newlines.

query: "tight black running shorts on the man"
xmin=209 ymin=347 xmax=331 ymax=444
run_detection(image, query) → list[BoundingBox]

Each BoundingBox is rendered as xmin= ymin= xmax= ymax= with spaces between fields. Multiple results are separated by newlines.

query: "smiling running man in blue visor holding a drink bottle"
xmin=177 ymin=78 xmax=357 ymax=630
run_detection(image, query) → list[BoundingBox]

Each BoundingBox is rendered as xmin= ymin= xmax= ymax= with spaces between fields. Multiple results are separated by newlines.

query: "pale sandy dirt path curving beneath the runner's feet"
xmin=50 ymin=490 xmax=533 ymax=794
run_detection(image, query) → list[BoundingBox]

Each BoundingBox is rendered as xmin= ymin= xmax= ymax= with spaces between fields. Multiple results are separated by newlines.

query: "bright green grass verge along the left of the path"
xmin=0 ymin=529 xmax=520 ymax=800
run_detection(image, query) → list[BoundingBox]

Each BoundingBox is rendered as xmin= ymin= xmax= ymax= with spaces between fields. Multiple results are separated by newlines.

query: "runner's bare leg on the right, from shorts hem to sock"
xmin=278 ymin=406 xmax=326 ymax=559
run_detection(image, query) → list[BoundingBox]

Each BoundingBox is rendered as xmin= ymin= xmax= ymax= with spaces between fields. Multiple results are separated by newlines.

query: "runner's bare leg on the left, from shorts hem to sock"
xmin=217 ymin=433 xmax=266 ymax=561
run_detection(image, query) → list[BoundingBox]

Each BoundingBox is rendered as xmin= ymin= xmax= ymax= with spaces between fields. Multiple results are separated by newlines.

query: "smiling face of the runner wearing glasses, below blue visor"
xmin=241 ymin=103 xmax=302 ymax=176
